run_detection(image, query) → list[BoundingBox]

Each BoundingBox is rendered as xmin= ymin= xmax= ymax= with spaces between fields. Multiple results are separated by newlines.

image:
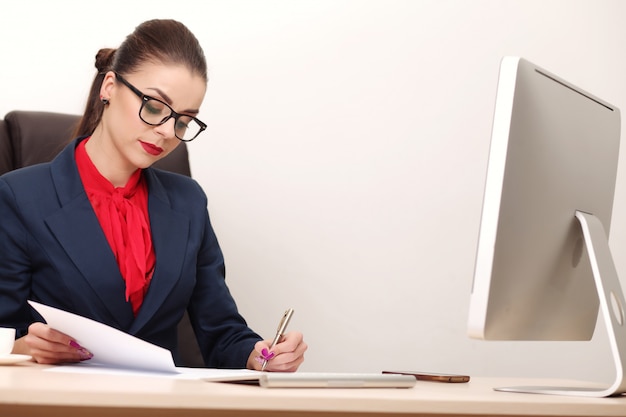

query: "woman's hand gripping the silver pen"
xmin=248 ymin=332 xmax=308 ymax=372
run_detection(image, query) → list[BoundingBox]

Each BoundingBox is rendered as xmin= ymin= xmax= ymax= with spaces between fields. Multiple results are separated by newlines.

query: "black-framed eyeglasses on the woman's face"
xmin=115 ymin=73 xmax=206 ymax=142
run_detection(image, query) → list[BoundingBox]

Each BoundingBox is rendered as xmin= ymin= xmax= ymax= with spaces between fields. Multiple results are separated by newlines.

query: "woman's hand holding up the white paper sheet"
xmin=13 ymin=323 xmax=93 ymax=364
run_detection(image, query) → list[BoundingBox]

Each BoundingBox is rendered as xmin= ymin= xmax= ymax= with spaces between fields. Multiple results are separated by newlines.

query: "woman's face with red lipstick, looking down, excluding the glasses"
xmin=95 ymin=64 xmax=206 ymax=176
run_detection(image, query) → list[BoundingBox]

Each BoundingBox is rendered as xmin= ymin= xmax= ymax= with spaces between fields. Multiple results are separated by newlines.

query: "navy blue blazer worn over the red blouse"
xmin=0 ymin=139 xmax=261 ymax=368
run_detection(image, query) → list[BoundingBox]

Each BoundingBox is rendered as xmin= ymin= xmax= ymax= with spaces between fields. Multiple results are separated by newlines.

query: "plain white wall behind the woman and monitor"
xmin=0 ymin=0 xmax=626 ymax=380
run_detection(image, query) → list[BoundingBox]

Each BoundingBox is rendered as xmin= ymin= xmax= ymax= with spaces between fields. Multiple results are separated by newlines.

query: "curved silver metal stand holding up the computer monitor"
xmin=495 ymin=211 xmax=626 ymax=397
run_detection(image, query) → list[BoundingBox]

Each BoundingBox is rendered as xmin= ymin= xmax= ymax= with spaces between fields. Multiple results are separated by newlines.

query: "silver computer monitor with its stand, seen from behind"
xmin=468 ymin=57 xmax=626 ymax=397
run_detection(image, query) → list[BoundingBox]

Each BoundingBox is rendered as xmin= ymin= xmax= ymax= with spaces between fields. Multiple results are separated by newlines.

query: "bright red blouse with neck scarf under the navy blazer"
xmin=76 ymin=138 xmax=156 ymax=316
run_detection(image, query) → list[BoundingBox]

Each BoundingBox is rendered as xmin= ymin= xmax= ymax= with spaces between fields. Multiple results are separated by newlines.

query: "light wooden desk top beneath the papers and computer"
xmin=0 ymin=363 xmax=626 ymax=417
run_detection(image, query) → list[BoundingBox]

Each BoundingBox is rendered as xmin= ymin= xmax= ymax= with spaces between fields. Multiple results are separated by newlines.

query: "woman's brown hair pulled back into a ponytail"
xmin=74 ymin=19 xmax=208 ymax=137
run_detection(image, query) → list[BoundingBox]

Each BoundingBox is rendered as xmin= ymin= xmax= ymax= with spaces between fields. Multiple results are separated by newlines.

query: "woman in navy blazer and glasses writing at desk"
xmin=0 ymin=20 xmax=307 ymax=371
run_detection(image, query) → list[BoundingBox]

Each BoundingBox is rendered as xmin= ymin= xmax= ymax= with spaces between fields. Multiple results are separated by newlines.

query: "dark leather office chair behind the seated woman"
xmin=0 ymin=111 xmax=204 ymax=367
